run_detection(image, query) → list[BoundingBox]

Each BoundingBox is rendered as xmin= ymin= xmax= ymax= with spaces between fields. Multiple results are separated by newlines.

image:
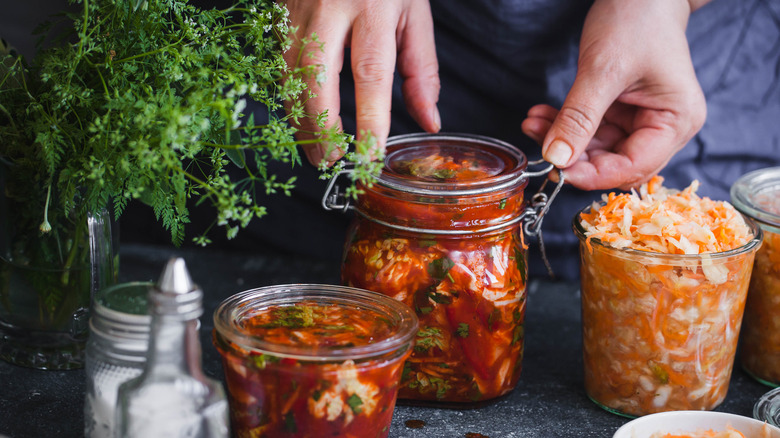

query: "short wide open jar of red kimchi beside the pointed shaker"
xmin=214 ymin=284 xmax=417 ymax=438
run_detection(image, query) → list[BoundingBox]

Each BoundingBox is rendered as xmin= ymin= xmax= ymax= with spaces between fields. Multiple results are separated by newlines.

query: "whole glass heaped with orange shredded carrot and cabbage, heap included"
xmin=573 ymin=178 xmax=762 ymax=417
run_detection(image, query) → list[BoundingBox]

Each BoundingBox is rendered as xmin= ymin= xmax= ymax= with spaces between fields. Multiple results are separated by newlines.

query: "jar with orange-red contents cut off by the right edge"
xmin=731 ymin=167 xmax=780 ymax=387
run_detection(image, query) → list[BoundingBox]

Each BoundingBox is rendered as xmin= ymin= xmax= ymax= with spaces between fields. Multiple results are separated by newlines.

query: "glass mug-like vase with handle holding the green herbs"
xmin=0 ymin=178 xmax=116 ymax=370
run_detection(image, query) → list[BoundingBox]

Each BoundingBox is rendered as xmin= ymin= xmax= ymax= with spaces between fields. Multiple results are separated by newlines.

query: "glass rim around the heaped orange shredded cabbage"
xmin=572 ymin=203 xmax=764 ymax=265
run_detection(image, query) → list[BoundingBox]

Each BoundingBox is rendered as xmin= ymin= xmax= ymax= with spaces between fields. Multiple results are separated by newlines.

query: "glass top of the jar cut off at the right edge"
xmin=731 ymin=167 xmax=780 ymax=228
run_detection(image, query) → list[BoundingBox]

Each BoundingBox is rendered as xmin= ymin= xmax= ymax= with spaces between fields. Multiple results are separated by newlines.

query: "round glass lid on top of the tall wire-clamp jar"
xmin=378 ymin=134 xmax=527 ymax=195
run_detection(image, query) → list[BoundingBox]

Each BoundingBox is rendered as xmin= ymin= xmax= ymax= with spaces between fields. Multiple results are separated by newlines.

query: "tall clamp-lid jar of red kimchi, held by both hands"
xmin=325 ymin=134 xmax=562 ymax=406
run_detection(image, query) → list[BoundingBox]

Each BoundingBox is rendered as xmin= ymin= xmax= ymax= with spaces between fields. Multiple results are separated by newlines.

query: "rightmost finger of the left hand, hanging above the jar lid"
xmin=398 ymin=1 xmax=441 ymax=132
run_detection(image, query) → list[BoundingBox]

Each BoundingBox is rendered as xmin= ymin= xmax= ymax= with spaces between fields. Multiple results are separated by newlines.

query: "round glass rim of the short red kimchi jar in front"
xmin=214 ymin=283 xmax=419 ymax=362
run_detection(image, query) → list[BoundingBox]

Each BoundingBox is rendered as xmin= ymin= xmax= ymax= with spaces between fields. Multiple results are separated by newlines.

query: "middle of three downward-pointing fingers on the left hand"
xmin=351 ymin=7 xmax=398 ymax=155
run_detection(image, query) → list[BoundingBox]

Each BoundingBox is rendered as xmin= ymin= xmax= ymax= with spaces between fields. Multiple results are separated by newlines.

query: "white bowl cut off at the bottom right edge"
xmin=612 ymin=411 xmax=780 ymax=438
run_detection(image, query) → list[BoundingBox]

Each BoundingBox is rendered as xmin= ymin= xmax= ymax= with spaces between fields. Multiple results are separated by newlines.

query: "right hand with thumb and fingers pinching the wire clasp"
xmin=522 ymin=0 xmax=706 ymax=190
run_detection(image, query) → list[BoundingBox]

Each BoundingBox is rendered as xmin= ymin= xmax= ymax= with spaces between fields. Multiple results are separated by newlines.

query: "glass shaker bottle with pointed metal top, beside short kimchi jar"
xmin=116 ymin=258 xmax=228 ymax=438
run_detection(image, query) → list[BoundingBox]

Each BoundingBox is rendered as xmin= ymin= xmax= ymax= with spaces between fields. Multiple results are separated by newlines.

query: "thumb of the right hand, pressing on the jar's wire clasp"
xmin=542 ymin=71 xmax=621 ymax=168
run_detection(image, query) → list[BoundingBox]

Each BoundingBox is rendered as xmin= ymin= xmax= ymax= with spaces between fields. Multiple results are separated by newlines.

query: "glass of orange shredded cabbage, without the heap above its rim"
xmin=572 ymin=206 xmax=762 ymax=417
